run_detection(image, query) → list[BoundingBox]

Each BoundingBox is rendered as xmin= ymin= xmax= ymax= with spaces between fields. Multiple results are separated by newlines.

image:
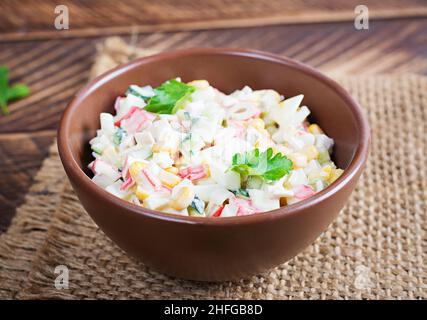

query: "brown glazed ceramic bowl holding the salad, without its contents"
xmin=58 ymin=49 xmax=370 ymax=281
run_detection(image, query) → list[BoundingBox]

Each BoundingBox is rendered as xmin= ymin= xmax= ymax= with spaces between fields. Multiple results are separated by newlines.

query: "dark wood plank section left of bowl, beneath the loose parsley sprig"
xmin=0 ymin=39 xmax=96 ymax=132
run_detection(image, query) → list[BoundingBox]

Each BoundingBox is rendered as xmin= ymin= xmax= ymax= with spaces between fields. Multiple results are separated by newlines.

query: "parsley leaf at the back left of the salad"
xmin=144 ymin=79 xmax=196 ymax=114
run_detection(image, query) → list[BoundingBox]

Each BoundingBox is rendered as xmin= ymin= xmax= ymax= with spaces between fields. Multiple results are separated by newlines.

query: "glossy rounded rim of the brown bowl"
xmin=57 ymin=48 xmax=371 ymax=226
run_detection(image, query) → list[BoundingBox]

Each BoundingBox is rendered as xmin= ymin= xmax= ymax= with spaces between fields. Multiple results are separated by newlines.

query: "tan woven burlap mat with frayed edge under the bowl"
xmin=0 ymin=40 xmax=427 ymax=299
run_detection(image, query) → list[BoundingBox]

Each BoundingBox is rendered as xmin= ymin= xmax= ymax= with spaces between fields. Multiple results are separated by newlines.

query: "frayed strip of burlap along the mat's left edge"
xmin=0 ymin=145 xmax=65 ymax=298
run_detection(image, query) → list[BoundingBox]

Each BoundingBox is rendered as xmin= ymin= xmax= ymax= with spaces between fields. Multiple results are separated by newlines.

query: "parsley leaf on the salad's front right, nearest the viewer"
xmin=230 ymin=148 xmax=292 ymax=182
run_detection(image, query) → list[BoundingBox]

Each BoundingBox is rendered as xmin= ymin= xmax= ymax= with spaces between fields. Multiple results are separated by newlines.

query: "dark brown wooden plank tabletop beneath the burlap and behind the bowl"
xmin=0 ymin=0 xmax=427 ymax=232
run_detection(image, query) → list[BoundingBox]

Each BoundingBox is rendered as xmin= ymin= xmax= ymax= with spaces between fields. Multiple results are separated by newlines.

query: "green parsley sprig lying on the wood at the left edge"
xmin=0 ymin=66 xmax=30 ymax=115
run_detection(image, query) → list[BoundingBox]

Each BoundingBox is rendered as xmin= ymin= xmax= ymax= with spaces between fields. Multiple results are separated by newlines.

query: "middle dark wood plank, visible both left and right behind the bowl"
xmin=0 ymin=19 xmax=427 ymax=133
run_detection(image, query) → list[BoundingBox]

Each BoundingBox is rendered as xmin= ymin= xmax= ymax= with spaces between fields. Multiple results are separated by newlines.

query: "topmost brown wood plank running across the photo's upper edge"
xmin=0 ymin=0 xmax=427 ymax=41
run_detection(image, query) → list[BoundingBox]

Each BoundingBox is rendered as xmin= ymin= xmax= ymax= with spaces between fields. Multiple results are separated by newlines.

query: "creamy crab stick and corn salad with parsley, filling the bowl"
xmin=89 ymin=79 xmax=343 ymax=218
